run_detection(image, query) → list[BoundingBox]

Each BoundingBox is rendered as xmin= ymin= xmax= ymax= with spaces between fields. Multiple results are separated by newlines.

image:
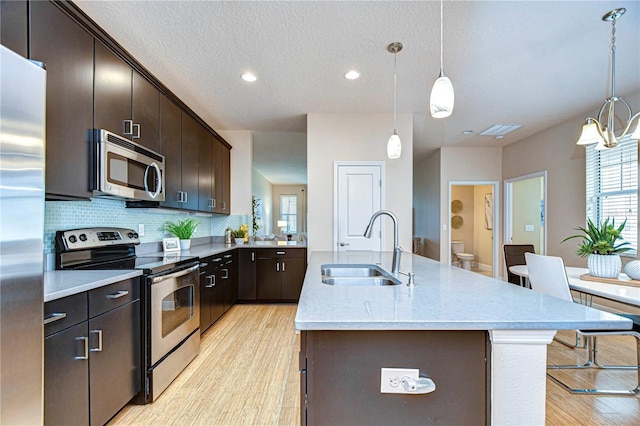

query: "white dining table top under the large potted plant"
xmin=509 ymin=265 xmax=640 ymax=308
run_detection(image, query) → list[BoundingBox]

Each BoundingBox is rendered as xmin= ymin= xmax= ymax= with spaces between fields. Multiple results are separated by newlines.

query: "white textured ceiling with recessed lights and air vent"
xmin=76 ymin=1 xmax=640 ymax=183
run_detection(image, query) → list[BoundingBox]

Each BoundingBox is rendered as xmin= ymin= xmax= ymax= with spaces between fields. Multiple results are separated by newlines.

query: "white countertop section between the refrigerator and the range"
xmin=44 ymin=270 xmax=142 ymax=302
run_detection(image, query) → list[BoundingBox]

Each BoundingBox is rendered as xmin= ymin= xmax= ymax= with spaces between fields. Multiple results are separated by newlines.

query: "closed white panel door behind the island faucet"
xmin=334 ymin=162 xmax=384 ymax=251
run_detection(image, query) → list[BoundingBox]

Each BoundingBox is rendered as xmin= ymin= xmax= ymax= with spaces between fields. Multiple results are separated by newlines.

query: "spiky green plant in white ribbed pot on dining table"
xmin=562 ymin=218 xmax=631 ymax=278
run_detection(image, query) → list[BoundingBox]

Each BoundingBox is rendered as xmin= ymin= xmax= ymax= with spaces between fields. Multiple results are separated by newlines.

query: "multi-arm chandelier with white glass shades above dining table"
xmin=577 ymin=7 xmax=640 ymax=150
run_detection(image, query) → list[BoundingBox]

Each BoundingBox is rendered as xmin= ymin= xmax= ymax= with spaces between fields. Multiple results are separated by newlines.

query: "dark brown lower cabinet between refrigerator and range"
xmin=44 ymin=279 xmax=142 ymax=425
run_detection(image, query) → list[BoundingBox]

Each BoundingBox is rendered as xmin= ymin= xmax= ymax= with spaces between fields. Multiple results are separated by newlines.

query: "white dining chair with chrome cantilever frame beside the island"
xmin=525 ymin=253 xmax=640 ymax=395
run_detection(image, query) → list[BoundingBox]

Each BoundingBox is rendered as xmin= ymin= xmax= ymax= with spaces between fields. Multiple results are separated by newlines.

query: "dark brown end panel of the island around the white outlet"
xmin=300 ymin=330 xmax=490 ymax=426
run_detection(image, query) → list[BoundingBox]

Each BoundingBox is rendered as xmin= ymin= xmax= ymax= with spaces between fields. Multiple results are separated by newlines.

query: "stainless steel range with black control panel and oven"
xmin=56 ymin=228 xmax=200 ymax=404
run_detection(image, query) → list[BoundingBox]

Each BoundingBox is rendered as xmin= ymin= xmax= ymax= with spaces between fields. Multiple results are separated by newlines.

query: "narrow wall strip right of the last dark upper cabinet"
xmin=218 ymin=130 xmax=253 ymax=215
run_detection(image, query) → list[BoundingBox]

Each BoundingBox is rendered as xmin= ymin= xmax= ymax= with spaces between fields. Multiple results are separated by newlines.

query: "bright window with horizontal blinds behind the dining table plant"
xmin=586 ymin=138 xmax=638 ymax=256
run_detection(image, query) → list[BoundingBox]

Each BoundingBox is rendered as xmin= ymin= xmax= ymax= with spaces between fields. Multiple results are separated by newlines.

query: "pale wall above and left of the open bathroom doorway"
xmin=440 ymin=148 xmax=500 ymax=262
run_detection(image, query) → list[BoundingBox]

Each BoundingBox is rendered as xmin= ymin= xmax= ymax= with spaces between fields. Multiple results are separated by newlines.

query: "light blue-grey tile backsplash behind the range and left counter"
xmin=44 ymin=198 xmax=251 ymax=253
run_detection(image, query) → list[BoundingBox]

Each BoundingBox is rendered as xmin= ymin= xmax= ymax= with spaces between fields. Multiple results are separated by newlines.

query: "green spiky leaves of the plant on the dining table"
xmin=562 ymin=218 xmax=631 ymax=257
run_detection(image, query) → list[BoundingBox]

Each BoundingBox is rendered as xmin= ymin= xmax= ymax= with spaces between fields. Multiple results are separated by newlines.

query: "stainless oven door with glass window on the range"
xmin=149 ymin=264 xmax=200 ymax=366
